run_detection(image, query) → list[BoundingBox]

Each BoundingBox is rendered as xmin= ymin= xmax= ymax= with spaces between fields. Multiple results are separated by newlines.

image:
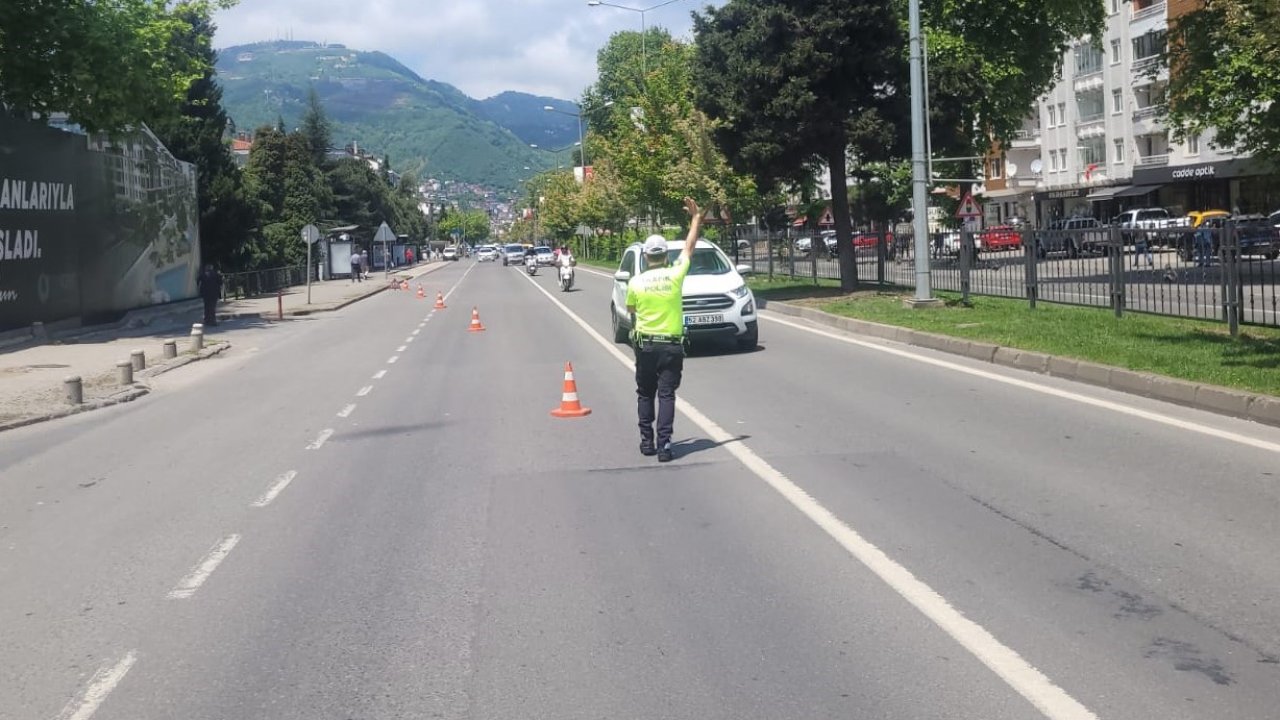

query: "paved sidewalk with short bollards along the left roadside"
xmin=0 ymin=261 xmax=448 ymax=430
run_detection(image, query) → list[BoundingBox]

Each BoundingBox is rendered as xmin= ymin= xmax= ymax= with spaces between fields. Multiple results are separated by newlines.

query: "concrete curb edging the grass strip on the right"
xmin=762 ymin=301 xmax=1280 ymax=427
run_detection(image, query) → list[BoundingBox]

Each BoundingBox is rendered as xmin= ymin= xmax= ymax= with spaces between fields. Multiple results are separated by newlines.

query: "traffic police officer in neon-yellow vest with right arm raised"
xmin=627 ymin=197 xmax=703 ymax=462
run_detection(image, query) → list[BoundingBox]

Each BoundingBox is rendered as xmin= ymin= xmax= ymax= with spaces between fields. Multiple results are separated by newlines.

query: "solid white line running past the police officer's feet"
xmin=526 ymin=269 xmax=1097 ymax=720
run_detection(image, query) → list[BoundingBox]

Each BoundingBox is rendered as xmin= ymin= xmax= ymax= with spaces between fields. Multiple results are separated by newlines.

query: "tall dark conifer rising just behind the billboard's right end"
xmin=147 ymin=4 xmax=257 ymax=268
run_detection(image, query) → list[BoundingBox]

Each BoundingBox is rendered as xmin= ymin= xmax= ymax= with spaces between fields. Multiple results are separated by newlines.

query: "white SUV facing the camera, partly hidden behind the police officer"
xmin=609 ymin=240 xmax=760 ymax=350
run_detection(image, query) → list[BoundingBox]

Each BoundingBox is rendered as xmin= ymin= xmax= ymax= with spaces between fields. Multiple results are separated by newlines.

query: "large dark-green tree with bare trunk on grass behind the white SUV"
xmin=694 ymin=0 xmax=906 ymax=290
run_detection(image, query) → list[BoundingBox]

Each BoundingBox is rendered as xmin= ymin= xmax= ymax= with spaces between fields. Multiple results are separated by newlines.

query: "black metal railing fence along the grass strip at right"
xmin=724 ymin=222 xmax=1280 ymax=333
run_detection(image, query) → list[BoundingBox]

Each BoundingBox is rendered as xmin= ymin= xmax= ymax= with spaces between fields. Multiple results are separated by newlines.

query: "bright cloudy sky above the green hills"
xmin=214 ymin=0 xmax=722 ymax=100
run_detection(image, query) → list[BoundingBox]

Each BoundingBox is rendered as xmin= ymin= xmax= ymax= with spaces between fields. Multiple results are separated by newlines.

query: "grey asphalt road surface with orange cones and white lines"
xmin=0 ymin=261 xmax=1280 ymax=720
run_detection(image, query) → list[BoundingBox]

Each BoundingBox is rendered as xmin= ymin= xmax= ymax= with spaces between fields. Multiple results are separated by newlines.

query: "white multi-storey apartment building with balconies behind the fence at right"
xmin=983 ymin=0 xmax=1280 ymax=225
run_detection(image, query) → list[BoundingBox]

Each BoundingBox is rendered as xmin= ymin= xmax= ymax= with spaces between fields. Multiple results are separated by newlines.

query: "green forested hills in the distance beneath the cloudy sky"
xmin=218 ymin=41 xmax=577 ymax=190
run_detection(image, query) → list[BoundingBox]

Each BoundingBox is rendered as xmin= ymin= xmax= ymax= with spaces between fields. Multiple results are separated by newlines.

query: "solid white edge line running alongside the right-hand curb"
xmin=760 ymin=314 xmax=1280 ymax=452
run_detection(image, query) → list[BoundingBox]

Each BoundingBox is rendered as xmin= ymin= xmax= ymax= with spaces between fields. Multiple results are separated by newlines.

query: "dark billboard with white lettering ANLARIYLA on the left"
xmin=0 ymin=117 xmax=200 ymax=332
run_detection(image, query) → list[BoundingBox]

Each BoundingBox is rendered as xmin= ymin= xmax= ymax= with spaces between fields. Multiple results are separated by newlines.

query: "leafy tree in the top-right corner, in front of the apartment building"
xmin=1165 ymin=0 xmax=1280 ymax=164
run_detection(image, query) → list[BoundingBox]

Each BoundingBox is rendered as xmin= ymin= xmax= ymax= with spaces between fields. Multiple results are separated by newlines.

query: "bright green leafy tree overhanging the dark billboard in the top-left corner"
xmin=0 ymin=0 xmax=234 ymax=133
